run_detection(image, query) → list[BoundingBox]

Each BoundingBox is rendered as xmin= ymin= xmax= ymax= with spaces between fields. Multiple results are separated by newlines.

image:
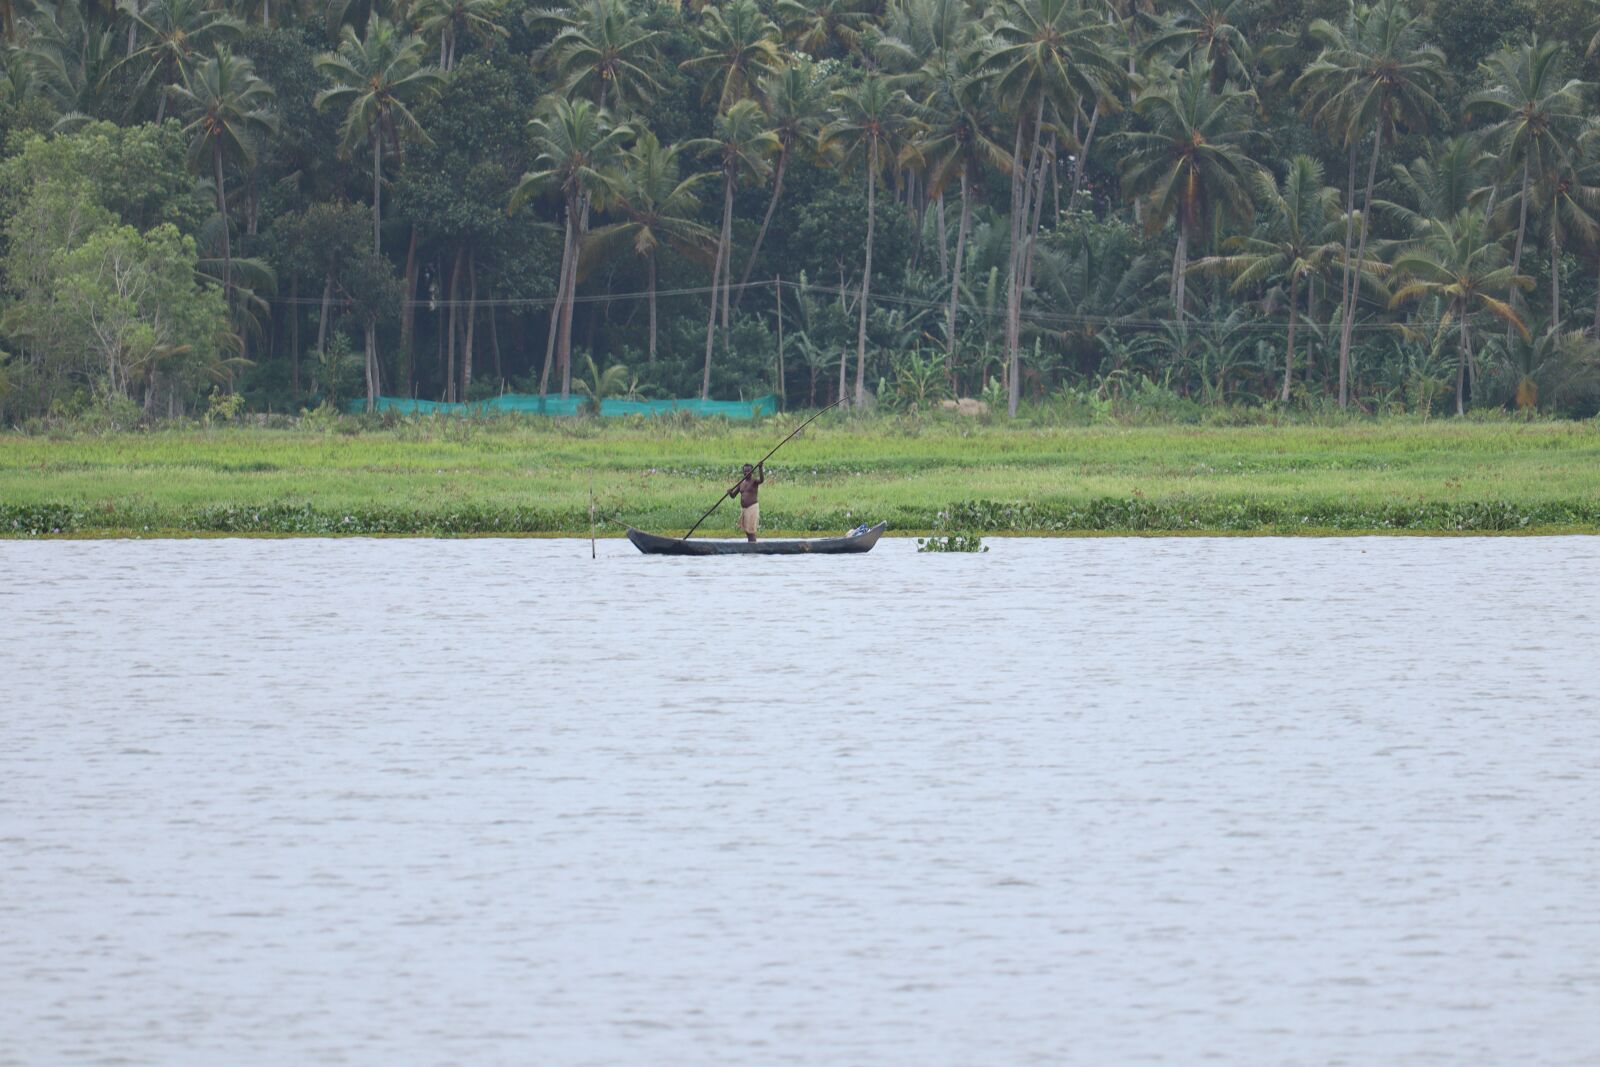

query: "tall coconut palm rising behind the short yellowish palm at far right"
xmin=1462 ymin=37 xmax=1587 ymax=331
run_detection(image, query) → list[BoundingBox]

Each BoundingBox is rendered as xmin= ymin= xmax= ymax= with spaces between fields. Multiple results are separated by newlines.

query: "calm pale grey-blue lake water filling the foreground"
xmin=0 ymin=537 xmax=1600 ymax=1067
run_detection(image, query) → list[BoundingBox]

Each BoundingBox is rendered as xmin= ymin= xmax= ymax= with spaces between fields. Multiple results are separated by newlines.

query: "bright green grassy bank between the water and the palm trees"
xmin=0 ymin=416 xmax=1600 ymax=536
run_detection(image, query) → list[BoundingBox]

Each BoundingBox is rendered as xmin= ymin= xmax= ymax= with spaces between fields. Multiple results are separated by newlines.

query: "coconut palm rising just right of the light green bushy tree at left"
xmin=173 ymin=48 xmax=278 ymax=296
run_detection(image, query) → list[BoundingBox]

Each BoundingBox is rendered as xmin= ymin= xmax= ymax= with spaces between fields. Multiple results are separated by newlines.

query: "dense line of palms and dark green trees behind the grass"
xmin=0 ymin=0 xmax=1600 ymax=419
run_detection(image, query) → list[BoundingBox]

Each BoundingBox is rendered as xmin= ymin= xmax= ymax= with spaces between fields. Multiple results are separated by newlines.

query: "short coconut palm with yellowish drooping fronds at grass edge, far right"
xmin=1389 ymin=208 xmax=1533 ymax=414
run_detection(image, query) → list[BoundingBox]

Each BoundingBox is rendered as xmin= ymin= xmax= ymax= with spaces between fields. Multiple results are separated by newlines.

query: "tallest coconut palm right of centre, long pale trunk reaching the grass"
xmin=984 ymin=0 xmax=1128 ymax=416
